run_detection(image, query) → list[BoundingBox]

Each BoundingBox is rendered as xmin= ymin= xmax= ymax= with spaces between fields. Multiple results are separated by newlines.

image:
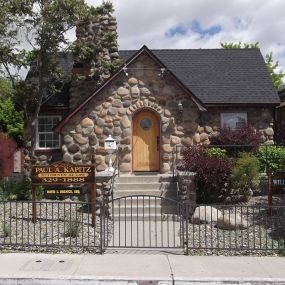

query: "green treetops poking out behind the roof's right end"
xmin=220 ymin=42 xmax=285 ymax=91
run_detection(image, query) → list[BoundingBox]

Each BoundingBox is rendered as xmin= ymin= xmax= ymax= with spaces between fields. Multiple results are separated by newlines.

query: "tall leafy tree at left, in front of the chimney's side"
xmin=0 ymin=0 xmax=92 ymax=154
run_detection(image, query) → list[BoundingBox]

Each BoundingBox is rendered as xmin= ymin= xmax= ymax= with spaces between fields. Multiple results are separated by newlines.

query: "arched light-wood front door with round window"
xmin=133 ymin=111 xmax=160 ymax=171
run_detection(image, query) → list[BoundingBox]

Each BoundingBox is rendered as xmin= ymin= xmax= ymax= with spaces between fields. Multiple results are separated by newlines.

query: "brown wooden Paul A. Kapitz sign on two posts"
xmin=32 ymin=161 xmax=96 ymax=226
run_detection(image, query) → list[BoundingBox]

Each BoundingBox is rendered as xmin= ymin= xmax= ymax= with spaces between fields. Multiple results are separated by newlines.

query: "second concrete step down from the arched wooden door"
xmin=115 ymin=181 xmax=175 ymax=191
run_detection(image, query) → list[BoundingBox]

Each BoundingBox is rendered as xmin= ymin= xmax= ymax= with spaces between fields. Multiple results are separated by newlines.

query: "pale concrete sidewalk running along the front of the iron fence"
xmin=0 ymin=253 xmax=285 ymax=285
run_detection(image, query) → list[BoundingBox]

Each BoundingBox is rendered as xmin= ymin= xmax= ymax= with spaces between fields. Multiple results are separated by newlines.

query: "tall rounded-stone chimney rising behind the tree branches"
xmin=69 ymin=3 xmax=122 ymax=109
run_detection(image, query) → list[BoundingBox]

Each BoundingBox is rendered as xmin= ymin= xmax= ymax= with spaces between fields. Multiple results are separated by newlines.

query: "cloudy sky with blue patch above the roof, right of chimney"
xmin=86 ymin=0 xmax=285 ymax=77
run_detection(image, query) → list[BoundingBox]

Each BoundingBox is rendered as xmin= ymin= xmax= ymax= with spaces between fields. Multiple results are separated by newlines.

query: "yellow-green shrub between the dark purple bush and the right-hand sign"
xmin=231 ymin=153 xmax=259 ymax=200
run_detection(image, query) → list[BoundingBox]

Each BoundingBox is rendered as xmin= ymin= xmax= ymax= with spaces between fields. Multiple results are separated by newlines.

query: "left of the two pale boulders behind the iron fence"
xmin=191 ymin=206 xmax=222 ymax=224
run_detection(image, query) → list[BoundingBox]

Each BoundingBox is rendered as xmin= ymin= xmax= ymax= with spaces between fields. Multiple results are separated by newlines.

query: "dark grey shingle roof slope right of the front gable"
xmin=120 ymin=49 xmax=280 ymax=104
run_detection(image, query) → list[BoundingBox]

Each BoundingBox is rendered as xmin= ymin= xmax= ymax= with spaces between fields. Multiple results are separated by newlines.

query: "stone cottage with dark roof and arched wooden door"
xmin=27 ymin=15 xmax=280 ymax=173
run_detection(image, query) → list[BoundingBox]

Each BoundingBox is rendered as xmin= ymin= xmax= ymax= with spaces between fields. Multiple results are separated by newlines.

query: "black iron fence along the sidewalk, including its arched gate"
xmin=0 ymin=196 xmax=285 ymax=253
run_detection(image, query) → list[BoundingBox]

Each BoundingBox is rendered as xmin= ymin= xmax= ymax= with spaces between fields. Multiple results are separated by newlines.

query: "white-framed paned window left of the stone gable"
xmin=37 ymin=116 xmax=61 ymax=149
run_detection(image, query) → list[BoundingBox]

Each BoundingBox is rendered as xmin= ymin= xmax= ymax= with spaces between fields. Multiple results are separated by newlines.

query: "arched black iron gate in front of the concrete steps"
xmin=101 ymin=195 xmax=188 ymax=249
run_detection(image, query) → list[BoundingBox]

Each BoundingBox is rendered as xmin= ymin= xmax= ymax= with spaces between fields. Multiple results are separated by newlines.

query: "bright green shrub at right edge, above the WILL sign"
xmin=257 ymin=145 xmax=285 ymax=172
